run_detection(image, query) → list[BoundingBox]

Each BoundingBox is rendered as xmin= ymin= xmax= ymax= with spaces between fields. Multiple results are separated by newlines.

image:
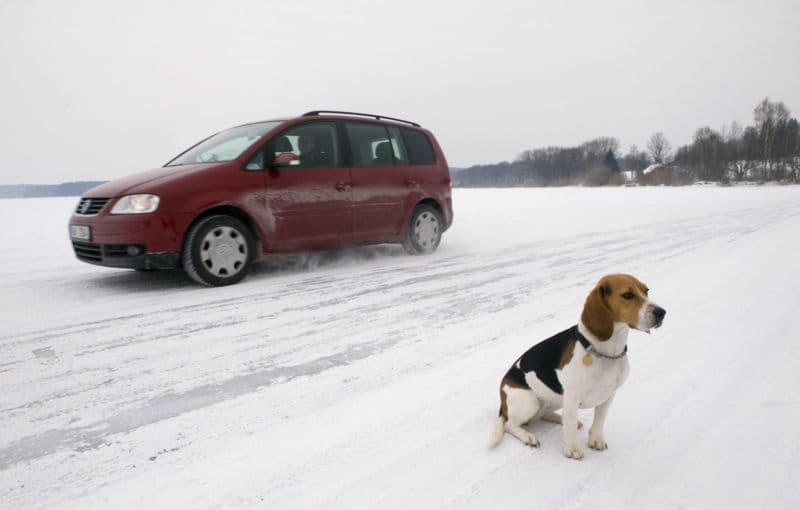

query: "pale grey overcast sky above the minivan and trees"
xmin=0 ymin=0 xmax=800 ymax=184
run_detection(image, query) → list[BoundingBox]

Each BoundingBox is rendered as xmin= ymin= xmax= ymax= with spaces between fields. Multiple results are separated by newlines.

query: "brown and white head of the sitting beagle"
xmin=581 ymin=274 xmax=667 ymax=340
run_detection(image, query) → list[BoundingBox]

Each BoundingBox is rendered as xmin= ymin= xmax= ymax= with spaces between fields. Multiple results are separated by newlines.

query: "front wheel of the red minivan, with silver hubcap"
xmin=181 ymin=215 xmax=255 ymax=287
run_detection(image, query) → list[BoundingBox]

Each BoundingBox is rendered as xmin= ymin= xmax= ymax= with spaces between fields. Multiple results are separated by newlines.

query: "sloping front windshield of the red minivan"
xmin=167 ymin=121 xmax=281 ymax=166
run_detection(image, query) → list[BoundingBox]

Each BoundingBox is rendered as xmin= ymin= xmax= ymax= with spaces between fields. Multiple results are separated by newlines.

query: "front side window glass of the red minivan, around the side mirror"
xmin=245 ymin=122 xmax=342 ymax=170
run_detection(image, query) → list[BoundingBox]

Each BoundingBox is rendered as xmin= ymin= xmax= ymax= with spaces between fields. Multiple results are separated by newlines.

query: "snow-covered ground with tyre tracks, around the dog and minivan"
xmin=0 ymin=187 xmax=800 ymax=509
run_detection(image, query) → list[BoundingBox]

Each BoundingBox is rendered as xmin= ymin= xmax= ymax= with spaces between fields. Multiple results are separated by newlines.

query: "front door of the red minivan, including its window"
xmin=264 ymin=122 xmax=353 ymax=250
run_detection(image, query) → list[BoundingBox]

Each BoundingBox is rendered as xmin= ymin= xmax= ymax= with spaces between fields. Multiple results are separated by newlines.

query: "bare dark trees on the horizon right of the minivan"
xmin=453 ymin=98 xmax=800 ymax=187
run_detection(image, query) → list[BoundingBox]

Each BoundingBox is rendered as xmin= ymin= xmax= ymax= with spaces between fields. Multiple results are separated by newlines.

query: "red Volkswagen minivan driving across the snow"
xmin=69 ymin=111 xmax=453 ymax=286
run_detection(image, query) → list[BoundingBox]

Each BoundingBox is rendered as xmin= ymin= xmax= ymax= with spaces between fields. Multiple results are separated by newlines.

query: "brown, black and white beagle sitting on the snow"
xmin=487 ymin=274 xmax=667 ymax=460
